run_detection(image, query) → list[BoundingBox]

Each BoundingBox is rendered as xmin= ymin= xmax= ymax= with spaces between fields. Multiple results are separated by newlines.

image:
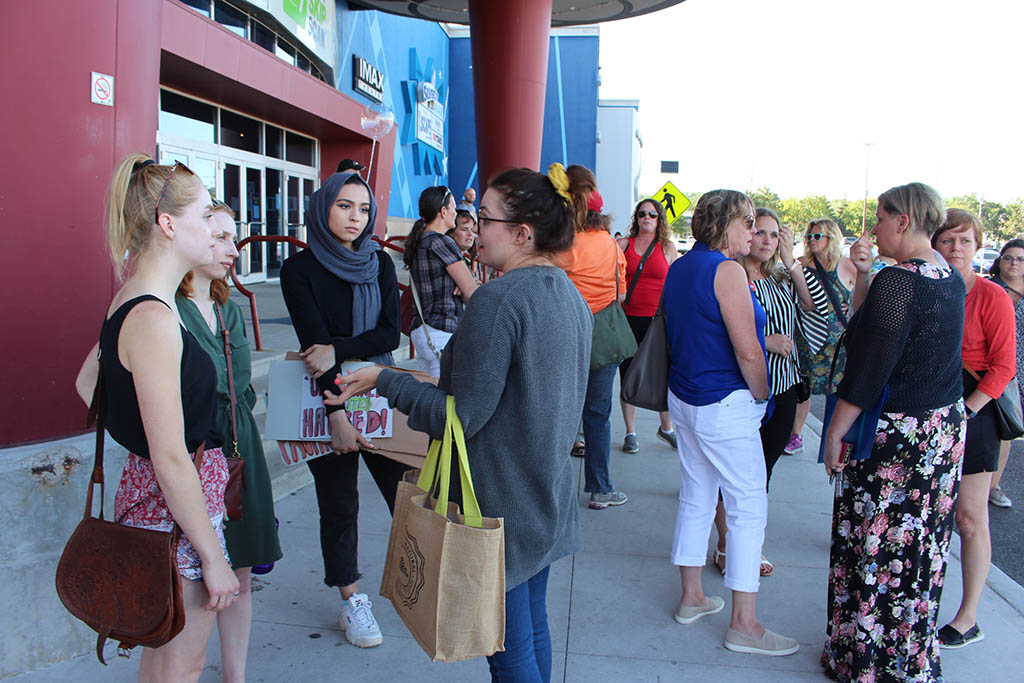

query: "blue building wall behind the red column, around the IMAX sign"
xmin=335 ymin=0 xmax=598 ymax=218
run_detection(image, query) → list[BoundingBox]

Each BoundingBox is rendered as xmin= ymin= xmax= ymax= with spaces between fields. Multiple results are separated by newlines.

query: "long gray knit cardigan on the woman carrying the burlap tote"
xmin=378 ymin=266 xmax=594 ymax=590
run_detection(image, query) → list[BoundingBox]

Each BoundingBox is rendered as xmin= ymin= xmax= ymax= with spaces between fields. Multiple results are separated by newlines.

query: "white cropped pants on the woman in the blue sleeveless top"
xmin=669 ymin=389 xmax=768 ymax=593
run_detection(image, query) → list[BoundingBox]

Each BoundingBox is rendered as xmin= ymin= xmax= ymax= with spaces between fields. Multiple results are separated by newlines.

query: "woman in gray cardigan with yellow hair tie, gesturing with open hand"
xmin=326 ymin=165 xmax=593 ymax=681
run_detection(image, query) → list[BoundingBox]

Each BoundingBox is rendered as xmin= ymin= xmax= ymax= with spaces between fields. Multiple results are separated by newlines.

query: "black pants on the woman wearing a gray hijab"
xmin=307 ymin=451 xmax=410 ymax=586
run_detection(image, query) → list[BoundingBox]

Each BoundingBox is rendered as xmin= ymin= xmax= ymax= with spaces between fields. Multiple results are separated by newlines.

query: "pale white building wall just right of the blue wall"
xmin=595 ymin=100 xmax=640 ymax=234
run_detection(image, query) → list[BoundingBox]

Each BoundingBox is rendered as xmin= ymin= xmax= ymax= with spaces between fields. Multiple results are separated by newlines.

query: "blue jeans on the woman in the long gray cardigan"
xmin=487 ymin=567 xmax=551 ymax=683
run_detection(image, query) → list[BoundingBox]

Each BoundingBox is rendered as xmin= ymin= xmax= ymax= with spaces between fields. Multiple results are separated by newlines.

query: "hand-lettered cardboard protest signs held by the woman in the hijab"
xmin=264 ymin=353 xmax=434 ymax=467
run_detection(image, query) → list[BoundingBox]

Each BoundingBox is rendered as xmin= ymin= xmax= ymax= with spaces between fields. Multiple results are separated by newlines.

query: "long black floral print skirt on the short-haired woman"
xmin=821 ymin=400 xmax=967 ymax=683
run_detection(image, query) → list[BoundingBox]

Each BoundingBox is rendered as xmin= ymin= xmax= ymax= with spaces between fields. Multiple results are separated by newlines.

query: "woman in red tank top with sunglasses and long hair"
xmin=617 ymin=199 xmax=679 ymax=453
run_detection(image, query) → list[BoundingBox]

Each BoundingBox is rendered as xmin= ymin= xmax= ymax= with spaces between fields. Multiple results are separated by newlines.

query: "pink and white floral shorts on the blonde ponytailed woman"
xmin=114 ymin=449 xmax=230 ymax=581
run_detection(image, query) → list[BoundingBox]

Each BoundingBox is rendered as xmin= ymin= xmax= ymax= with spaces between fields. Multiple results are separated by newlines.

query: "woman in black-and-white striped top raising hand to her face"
xmin=713 ymin=209 xmax=828 ymax=577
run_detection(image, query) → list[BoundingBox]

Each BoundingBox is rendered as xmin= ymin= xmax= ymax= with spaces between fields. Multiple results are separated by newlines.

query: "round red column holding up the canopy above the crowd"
xmin=469 ymin=0 xmax=552 ymax=186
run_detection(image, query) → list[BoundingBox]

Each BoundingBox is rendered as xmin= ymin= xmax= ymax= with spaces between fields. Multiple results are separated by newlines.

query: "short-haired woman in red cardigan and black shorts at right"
xmin=932 ymin=209 xmax=1017 ymax=649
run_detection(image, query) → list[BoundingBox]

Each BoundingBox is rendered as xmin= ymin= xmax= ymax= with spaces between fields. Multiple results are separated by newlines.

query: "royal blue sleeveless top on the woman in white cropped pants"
xmin=665 ymin=243 xmax=767 ymax=405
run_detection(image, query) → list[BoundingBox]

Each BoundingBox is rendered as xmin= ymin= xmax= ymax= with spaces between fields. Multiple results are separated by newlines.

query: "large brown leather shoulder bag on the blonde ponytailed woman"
xmin=56 ymin=366 xmax=196 ymax=665
